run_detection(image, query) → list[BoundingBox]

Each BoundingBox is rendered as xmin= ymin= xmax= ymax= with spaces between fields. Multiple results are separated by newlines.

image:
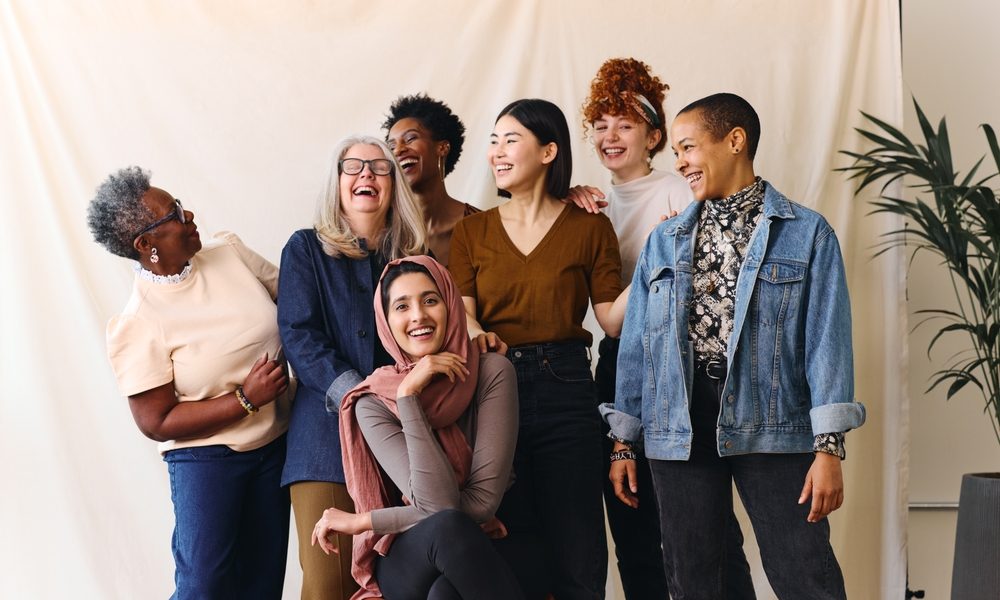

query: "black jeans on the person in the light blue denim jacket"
xmin=649 ymin=373 xmax=846 ymax=600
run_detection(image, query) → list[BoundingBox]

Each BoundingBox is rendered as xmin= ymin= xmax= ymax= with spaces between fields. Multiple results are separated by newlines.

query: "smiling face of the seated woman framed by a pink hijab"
xmin=386 ymin=273 xmax=448 ymax=362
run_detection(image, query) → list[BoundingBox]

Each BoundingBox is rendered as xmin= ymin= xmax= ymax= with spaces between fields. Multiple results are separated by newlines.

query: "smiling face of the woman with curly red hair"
xmin=591 ymin=114 xmax=661 ymax=184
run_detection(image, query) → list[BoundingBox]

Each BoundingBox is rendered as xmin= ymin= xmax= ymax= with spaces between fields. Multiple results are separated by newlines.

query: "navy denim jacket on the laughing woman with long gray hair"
xmin=278 ymin=229 xmax=394 ymax=485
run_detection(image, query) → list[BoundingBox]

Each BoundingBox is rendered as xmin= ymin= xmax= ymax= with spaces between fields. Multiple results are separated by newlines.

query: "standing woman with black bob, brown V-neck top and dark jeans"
xmin=450 ymin=99 xmax=624 ymax=599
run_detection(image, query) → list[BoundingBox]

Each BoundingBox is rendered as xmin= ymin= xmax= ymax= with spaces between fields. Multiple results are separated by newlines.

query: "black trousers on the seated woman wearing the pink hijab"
xmin=375 ymin=510 xmax=524 ymax=600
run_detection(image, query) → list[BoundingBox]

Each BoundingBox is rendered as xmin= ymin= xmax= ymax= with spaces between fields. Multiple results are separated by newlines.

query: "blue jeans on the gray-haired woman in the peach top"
xmin=163 ymin=436 xmax=288 ymax=600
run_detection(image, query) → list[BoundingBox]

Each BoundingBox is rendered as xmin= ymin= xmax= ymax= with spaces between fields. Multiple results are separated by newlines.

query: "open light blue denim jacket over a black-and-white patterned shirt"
xmin=601 ymin=182 xmax=865 ymax=460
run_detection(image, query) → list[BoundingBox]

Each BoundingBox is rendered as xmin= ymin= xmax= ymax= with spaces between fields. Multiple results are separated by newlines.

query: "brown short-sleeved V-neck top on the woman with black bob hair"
xmin=448 ymin=204 xmax=622 ymax=346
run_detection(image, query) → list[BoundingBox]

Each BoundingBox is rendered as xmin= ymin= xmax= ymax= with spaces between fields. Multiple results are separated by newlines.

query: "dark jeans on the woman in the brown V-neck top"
xmin=498 ymin=342 xmax=608 ymax=600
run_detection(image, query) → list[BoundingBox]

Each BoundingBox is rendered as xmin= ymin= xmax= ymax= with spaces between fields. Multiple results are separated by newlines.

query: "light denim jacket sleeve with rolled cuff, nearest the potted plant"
xmin=805 ymin=226 xmax=865 ymax=435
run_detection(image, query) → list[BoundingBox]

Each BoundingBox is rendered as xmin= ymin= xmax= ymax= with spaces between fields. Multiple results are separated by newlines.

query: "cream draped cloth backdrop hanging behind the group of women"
xmin=0 ymin=0 xmax=908 ymax=598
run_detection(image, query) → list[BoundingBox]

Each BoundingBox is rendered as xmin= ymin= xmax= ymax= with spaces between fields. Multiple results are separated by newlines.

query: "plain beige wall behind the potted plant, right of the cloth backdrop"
xmin=902 ymin=0 xmax=1000 ymax=598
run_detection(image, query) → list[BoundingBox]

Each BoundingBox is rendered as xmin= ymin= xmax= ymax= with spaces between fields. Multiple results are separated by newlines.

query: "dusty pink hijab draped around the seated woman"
xmin=340 ymin=256 xmax=479 ymax=600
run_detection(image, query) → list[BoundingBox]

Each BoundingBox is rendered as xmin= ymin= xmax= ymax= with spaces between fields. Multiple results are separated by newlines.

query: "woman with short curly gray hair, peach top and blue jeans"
xmin=87 ymin=167 xmax=291 ymax=599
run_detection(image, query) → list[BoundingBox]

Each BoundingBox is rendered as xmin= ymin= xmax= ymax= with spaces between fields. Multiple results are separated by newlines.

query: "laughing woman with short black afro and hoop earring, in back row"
xmin=382 ymin=94 xmax=479 ymax=266
